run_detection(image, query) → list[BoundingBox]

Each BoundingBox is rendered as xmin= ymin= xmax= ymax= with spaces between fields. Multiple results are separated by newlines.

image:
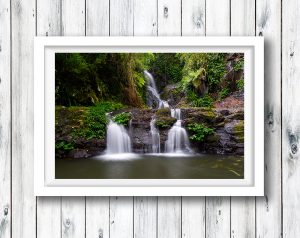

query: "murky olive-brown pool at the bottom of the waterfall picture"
xmin=55 ymin=154 xmax=244 ymax=179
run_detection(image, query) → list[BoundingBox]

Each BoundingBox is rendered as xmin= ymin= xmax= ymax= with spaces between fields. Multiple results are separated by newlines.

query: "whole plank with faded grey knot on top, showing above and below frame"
xmin=182 ymin=0 xmax=205 ymax=238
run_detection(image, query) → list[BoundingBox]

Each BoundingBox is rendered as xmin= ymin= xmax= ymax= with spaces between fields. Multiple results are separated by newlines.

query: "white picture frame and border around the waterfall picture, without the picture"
xmin=34 ymin=37 xmax=264 ymax=196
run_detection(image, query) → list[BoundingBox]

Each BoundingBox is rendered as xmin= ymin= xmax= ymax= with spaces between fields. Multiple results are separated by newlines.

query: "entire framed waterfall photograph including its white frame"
xmin=34 ymin=37 xmax=264 ymax=196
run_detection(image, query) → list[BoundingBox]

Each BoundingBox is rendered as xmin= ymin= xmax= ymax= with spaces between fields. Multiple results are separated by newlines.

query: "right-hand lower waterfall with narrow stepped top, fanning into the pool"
xmin=165 ymin=109 xmax=191 ymax=153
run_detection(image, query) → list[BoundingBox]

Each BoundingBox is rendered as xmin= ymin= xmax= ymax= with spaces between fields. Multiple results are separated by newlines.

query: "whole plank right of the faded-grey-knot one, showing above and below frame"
xmin=206 ymin=0 xmax=230 ymax=238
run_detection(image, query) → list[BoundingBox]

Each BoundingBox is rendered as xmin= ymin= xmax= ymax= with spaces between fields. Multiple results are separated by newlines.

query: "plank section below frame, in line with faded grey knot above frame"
xmin=182 ymin=197 xmax=205 ymax=238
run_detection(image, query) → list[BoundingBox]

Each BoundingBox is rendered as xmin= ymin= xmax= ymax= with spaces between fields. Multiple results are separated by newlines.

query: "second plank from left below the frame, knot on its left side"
xmin=61 ymin=197 xmax=85 ymax=238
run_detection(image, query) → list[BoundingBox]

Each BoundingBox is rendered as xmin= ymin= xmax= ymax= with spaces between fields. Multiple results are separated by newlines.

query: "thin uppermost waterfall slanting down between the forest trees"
xmin=144 ymin=70 xmax=169 ymax=108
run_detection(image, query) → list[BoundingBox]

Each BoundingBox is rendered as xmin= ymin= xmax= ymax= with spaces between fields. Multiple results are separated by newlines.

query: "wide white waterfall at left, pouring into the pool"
xmin=106 ymin=120 xmax=131 ymax=154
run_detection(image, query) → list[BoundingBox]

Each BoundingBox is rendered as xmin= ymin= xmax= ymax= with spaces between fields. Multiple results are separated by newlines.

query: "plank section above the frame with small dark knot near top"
xmin=158 ymin=0 xmax=181 ymax=36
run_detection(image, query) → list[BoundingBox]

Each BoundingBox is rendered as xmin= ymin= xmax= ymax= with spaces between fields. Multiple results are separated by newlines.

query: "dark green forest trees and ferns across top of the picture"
xmin=55 ymin=53 xmax=244 ymax=107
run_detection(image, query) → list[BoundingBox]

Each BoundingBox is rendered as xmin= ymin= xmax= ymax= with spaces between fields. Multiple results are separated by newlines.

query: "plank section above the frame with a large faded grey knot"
xmin=182 ymin=0 xmax=205 ymax=36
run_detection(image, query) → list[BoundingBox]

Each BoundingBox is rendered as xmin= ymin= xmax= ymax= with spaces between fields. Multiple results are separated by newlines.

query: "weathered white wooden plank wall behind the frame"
xmin=0 ymin=0 xmax=292 ymax=238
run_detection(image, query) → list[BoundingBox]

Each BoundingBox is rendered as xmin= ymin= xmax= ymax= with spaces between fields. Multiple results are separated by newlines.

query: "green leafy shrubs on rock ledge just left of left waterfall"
xmin=72 ymin=102 xmax=124 ymax=139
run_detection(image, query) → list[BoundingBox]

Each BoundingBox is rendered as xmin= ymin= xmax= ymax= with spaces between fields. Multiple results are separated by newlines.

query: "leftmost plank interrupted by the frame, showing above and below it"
xmin=36 ymin=0 xmax=61 ymax=238
